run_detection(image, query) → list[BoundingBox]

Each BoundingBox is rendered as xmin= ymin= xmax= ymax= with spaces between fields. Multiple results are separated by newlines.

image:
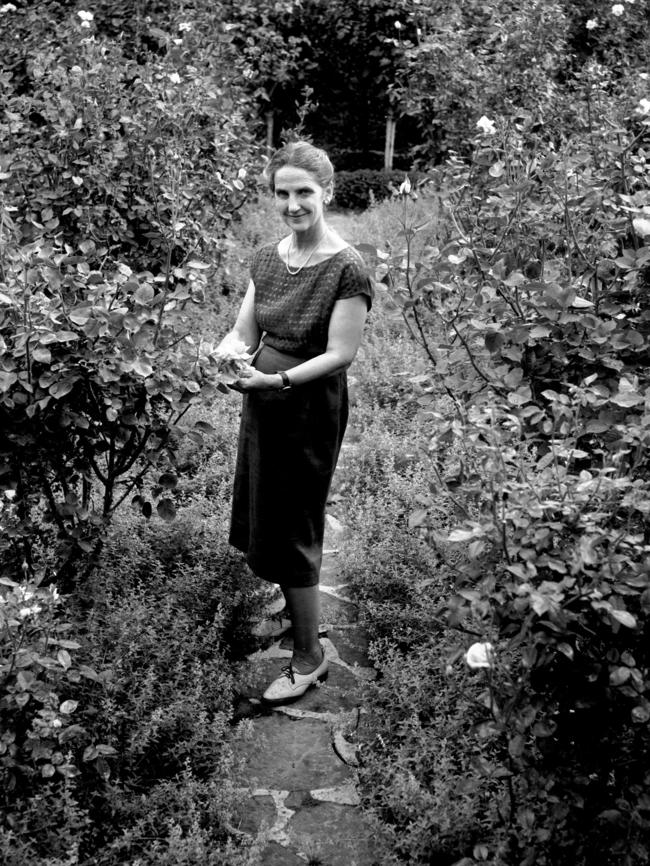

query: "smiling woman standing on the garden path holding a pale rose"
xmin=216 ymin=141 xmax=373 ymax=704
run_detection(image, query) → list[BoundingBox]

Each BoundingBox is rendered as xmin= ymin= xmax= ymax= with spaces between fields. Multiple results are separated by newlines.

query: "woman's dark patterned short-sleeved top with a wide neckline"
xmin=251 ymin=244 xmax=373 ymax=358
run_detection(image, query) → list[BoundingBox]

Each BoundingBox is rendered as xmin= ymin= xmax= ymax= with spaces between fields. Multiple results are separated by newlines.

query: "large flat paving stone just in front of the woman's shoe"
xmin=239 ymin=714 xmax=350 ymax=791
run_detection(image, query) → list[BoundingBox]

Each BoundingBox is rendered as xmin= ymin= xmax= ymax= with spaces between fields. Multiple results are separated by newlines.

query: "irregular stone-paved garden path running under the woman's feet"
xmin=233 ymin=518 xmax=379 ymax=866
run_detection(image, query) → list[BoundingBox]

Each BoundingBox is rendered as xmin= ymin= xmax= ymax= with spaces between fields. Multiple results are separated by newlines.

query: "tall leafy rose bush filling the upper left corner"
xmin=0 ymin=2 xmax=256 ymax=270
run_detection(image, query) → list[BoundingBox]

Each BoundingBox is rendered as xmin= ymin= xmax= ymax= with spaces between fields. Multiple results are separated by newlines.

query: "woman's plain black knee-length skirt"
xmin=229 ymin=346 xmax=348 ymax=586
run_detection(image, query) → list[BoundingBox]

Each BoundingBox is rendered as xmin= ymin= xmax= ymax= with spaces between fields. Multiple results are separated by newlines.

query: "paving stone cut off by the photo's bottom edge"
xmin=287 ymin=803 xmax=378 ymax=866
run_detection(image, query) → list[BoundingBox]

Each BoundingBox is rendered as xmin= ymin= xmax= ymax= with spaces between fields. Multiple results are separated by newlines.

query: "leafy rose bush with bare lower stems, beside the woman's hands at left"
xmin=0 ymin=224 xmax=230 ymax=588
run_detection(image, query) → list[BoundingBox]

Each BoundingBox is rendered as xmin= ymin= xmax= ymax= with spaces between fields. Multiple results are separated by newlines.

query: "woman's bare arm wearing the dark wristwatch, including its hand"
xmin=234 ymin=295 xmax=368 ymax=391
